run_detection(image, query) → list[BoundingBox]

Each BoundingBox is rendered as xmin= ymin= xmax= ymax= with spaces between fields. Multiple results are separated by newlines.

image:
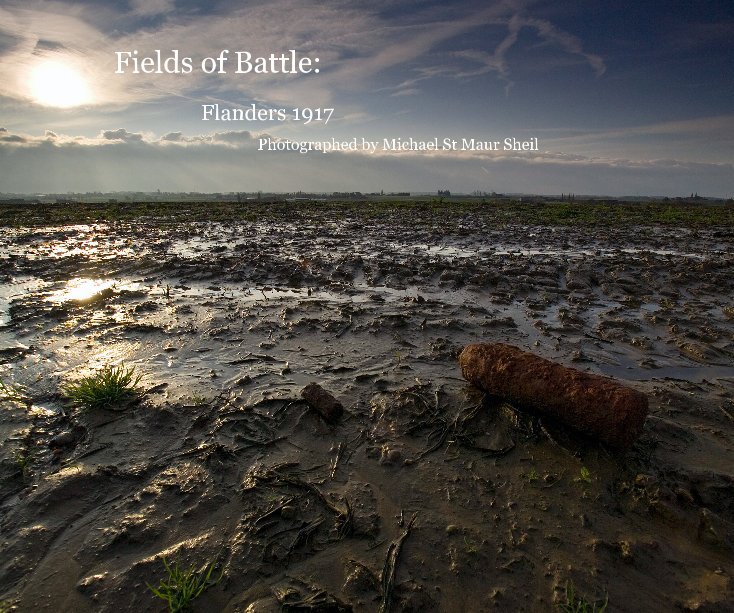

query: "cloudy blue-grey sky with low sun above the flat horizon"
xmin=0 ymin=0 xmax=734 ymax=198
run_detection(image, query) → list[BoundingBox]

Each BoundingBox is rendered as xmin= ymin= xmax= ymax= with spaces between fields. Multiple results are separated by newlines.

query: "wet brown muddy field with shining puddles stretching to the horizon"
xmin=0 ymin=204 xmax=734 ymax=613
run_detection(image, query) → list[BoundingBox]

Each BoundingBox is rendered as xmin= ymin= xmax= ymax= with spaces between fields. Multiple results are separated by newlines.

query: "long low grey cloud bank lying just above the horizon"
xmin=0 ymin=128 xmax=734 ymax=196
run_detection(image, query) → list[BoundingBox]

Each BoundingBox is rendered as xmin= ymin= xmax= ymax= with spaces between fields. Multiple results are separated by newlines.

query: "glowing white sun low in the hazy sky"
xmin=28 ymin=60 xmax=92 ymax=108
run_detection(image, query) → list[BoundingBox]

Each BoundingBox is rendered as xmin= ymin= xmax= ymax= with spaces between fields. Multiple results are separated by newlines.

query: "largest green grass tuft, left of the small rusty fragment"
xmin=62 ymin=366 xmax=142 ymax=409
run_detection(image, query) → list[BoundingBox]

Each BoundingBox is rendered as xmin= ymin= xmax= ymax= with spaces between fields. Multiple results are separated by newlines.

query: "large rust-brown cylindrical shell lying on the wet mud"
xmin=459 ymin=343 xmax=648 ymax=450
